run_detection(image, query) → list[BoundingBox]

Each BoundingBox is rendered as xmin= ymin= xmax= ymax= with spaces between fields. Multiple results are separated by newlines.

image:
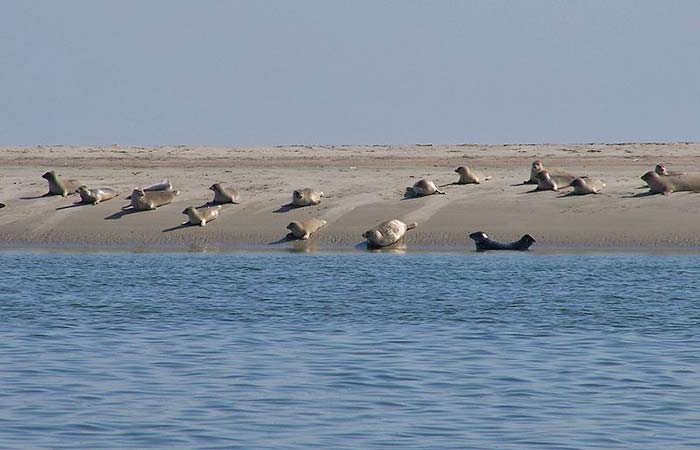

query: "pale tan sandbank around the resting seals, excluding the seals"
xmin=0 ymin=143 xmax=700 ymax=251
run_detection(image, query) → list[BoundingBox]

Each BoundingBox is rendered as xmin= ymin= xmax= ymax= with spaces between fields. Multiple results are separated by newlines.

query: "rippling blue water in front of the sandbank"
xmin=0 ymin=252 xmax=700 ymax=449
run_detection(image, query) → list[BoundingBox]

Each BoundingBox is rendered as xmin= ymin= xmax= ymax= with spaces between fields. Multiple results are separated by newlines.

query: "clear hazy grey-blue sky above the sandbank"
xmin=0 ymin=0 xmax=700 ymax=145
